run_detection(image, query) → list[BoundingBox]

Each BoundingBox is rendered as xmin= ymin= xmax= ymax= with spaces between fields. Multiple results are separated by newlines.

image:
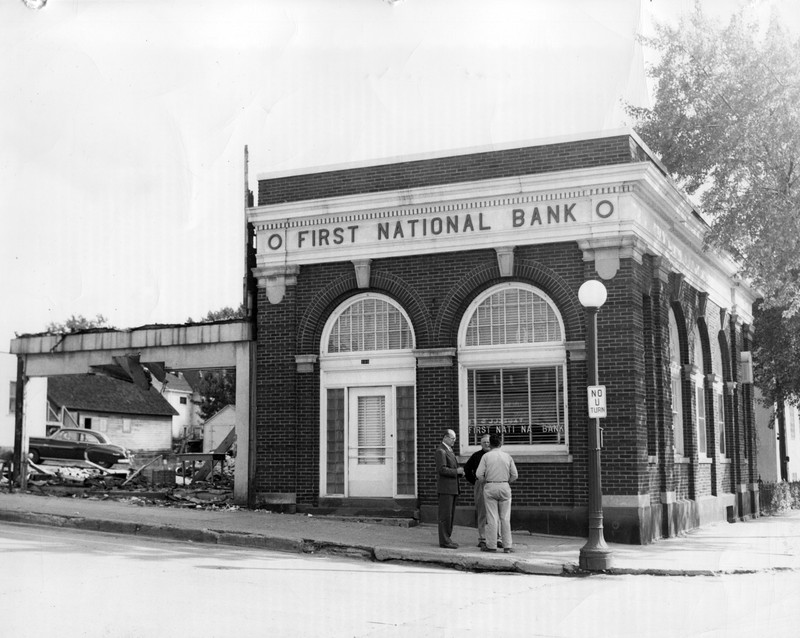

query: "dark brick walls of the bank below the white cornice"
xmin=255 ymin=242 xmax=749 ymax=528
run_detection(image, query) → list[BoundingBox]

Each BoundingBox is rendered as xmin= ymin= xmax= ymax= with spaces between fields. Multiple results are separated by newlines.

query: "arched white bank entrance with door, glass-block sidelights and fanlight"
xmin=320 ymin=293 xmax=416 ymax=498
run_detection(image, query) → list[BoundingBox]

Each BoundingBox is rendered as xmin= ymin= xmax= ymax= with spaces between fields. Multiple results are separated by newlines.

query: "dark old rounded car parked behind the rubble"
xmin=28 ymin=428 xmax=130 ymax=467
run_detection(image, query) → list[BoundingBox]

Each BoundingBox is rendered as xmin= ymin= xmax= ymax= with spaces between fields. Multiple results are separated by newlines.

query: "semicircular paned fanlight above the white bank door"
xmin=325 ymin=294 xmax=414 ymax=353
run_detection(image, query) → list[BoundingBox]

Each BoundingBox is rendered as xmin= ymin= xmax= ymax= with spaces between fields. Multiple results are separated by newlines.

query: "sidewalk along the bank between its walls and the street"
xmin=0 ymin=492 xmax=800 ymax=576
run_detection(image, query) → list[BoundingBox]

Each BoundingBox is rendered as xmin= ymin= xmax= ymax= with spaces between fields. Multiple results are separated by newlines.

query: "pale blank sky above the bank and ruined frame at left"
xmin=0 ymin=0 xmax=800 ymax=362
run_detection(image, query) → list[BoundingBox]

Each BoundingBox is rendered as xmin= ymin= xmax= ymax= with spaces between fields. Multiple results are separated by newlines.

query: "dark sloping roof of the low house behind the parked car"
xmin=47 ymin=374 xmax=178 ymax=416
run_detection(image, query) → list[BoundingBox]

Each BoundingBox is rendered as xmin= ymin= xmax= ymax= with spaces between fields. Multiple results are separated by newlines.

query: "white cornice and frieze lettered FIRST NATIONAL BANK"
xmin=248 ymin=162 xmax=757 ymax=320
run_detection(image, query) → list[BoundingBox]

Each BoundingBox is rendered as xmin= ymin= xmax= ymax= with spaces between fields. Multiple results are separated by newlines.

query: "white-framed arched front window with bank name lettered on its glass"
xmin=458 ymin=283 xmax=569 ymax=453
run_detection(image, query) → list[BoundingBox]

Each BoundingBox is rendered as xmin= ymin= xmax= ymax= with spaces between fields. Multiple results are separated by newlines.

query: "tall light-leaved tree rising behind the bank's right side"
xmin=628 ymin=3 xmax=800 ymax=314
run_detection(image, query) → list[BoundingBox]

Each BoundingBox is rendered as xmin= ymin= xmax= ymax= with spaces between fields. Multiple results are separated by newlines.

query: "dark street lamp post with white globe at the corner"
xmin=578 ymin=280 xmax=611 ymax=571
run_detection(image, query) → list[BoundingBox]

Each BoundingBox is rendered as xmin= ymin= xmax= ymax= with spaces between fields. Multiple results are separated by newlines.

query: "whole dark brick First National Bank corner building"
xmin=247 ymin=131 xmax=758 ymax=543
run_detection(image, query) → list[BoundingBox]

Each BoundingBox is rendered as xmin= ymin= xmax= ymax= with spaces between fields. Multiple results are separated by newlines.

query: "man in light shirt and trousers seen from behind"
xmin=475 ymin=434 xmax=519 ymax=553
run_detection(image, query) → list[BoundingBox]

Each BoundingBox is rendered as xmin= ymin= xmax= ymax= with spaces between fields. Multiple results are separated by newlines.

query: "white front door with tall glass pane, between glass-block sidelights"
xmin=347 ymin=387 xmax=395 ymax=497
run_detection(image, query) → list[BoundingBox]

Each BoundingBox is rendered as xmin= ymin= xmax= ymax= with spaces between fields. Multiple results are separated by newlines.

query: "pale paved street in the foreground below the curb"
xmin=0 ymin=524 xmax=800 ymax=638
